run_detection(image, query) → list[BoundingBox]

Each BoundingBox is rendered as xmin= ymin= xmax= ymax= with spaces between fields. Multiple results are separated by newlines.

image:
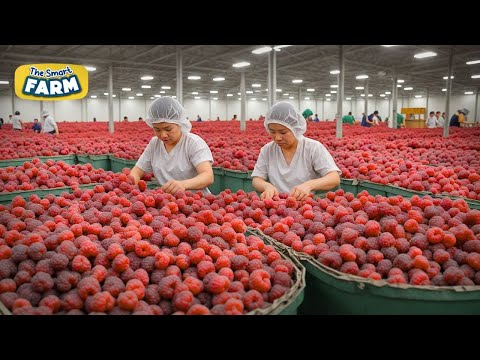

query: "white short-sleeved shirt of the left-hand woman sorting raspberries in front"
xmin=135 ymin=133 xmax=213 ymax=194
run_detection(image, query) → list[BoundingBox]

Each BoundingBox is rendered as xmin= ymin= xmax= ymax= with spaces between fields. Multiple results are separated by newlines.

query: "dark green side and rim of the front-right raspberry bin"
xmin=299 ymin=254 xmax=480 ymax=315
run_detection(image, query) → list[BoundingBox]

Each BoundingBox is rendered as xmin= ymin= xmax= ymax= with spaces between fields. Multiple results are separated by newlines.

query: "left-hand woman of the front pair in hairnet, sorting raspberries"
xmin=130 ymin=96 xmax=213 ymax=194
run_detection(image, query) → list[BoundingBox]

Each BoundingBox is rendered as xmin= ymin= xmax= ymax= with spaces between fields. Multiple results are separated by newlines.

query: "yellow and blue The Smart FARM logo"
xmin=15 ymin=64 xmax=88 ymax=100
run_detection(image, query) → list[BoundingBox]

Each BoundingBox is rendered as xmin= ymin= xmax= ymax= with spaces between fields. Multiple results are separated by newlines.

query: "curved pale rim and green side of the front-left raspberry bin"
xmin=245 ymin=228 xmax=305 ymax=315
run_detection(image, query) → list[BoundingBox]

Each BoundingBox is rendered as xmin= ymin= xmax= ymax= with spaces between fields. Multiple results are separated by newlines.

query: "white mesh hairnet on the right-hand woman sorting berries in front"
xmin=264 ymin=101 xmax=307 ymax=140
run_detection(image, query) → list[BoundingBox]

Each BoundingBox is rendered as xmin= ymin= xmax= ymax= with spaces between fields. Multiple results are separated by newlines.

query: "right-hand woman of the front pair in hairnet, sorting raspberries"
xmin=252 ymin=101 xmax=341 ymax=200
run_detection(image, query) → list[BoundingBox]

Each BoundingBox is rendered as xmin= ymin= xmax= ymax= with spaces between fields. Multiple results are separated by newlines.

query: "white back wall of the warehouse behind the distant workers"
xmin=0 ymin=95 xmax=480 ymax=122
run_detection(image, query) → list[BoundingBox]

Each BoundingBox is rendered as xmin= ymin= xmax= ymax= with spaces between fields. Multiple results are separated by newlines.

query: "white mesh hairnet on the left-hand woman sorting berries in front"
xmin=145 ymin=96 xmax=192 ymax=134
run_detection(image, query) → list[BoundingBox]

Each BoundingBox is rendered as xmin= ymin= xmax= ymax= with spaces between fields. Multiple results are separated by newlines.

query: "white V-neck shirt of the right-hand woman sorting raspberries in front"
xmin=252 ymin=137 xmax=342 ymax=193
